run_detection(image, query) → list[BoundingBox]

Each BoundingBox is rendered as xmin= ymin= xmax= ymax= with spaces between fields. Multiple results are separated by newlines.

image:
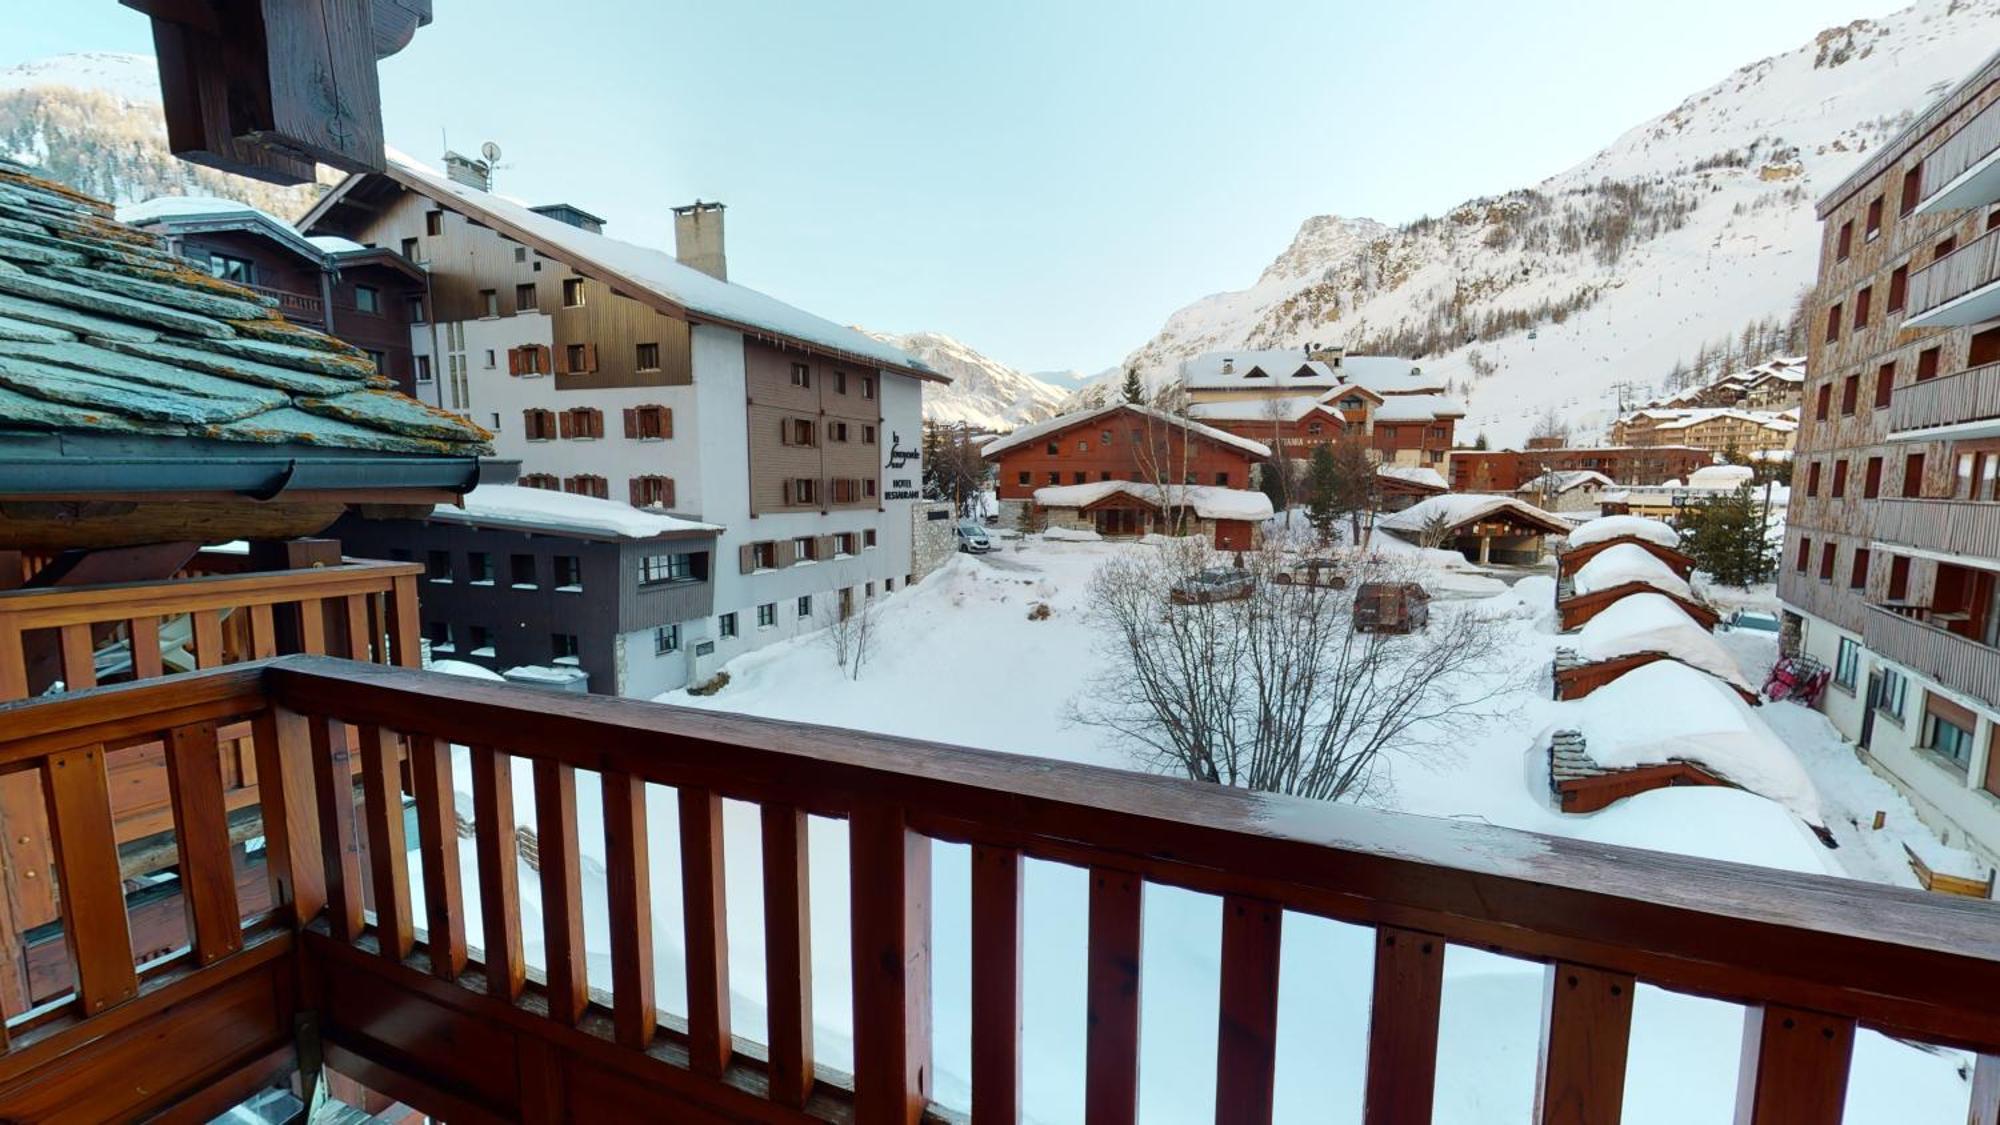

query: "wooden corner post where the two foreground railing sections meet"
xmin=252 ymin=709 xmax=326 ymax=927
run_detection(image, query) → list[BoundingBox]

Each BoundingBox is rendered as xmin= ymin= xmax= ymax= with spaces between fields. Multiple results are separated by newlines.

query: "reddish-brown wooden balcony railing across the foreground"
xmin=0 ymin=657 xmax=2000 ymax=1125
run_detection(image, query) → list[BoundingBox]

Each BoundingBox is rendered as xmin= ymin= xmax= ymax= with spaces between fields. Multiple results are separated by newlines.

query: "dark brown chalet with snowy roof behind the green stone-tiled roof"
xmin=118 ymin=196 xmax=434 ymax=400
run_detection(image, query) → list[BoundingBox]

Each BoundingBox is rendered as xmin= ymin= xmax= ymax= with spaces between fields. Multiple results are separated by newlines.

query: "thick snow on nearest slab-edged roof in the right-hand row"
xmin=1556 ymin=661 xmax=1824 ymax=825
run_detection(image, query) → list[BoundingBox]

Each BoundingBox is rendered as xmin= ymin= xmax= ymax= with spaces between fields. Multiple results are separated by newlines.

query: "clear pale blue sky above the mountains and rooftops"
xmin=0 ymin=0 xmax=1888 ymax=370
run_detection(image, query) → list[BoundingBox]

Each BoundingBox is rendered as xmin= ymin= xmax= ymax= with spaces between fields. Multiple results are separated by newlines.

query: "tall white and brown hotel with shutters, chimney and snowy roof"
xmin=300 ymin=156 xmax=944 ymax=665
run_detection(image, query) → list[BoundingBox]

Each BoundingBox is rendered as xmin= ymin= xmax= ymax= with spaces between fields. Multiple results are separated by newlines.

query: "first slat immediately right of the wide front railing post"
xmin=972 ymin=845 xmax=1022 ymax=1123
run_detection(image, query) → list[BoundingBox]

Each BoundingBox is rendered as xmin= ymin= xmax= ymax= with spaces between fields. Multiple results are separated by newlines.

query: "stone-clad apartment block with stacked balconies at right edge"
xmin=1778 ymin=46 xmax=2000 ymax=861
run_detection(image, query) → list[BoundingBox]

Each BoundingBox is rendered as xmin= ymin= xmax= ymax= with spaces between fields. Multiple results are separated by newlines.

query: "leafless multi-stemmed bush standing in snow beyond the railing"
xmin=1072 ymin=542 xmax=1518 ymax=801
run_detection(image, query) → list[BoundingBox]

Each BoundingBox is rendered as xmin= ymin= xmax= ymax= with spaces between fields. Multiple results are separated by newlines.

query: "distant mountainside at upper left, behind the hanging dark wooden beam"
xmin=0 ymin=52 xmax=320 ymax=216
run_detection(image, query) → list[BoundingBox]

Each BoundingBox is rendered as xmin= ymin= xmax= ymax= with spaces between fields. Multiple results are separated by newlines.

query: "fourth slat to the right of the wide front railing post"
xmin=1362 ymin=927 xmax=1444 ymax=1125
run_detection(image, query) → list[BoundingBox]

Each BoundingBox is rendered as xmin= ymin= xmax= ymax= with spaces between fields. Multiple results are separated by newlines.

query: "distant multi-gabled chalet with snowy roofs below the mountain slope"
xmin=1180 ymin=346 xmax=1466 ymax=466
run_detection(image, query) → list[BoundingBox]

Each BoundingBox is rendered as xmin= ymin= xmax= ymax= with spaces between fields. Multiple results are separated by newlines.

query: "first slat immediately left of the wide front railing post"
xmin=760 ymin=805 xmax=812 ymax=1107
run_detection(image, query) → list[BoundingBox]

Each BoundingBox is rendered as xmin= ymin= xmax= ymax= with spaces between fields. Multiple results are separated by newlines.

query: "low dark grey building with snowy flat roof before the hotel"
xmin=332 ymin=484 xmax=724 ymax=699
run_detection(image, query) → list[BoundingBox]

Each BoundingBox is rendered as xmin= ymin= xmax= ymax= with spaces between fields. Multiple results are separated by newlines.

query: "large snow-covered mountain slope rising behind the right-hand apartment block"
xmin=1112 ymin=0 xmax=2000 ymax=444
